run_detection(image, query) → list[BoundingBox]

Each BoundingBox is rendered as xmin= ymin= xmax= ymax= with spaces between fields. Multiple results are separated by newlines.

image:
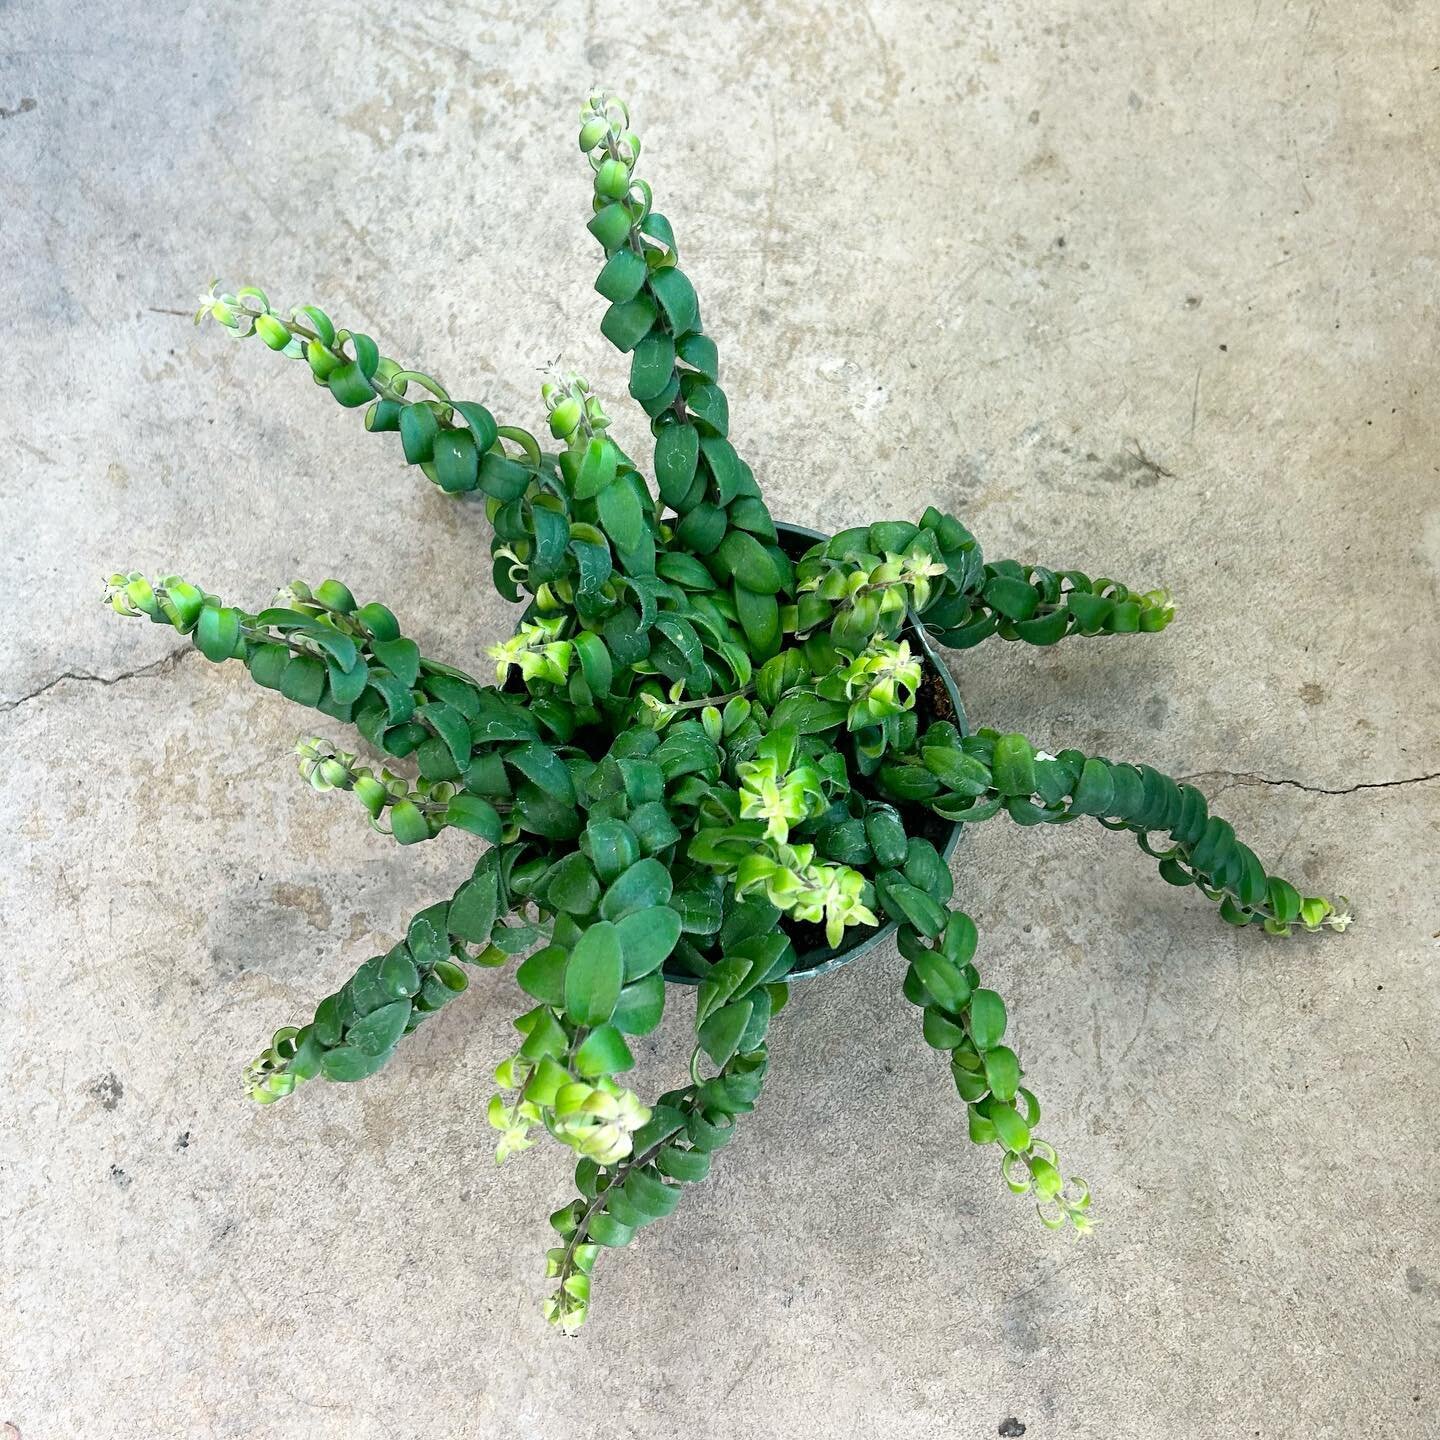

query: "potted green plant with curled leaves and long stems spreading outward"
xmin=107 ymin=87 xmax=1348 ymax=1329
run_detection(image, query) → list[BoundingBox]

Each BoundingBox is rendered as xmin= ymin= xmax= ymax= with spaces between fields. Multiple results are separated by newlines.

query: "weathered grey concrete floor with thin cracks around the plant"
xmin=0 ymin=0 xmax=1440 ymax=1440
